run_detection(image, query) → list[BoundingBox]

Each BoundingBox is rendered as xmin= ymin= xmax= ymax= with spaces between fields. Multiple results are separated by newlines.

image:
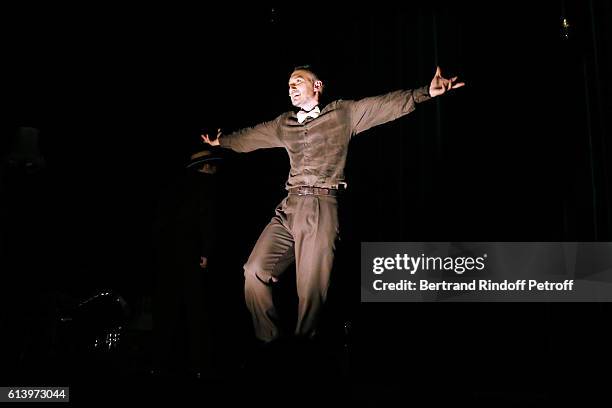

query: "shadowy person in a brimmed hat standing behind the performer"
xmin=153 ymin=145 xmax=222 ymax=378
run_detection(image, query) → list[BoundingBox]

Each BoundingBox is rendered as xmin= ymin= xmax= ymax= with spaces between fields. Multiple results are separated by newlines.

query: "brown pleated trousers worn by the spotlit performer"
xmin=244 ymin=194 xmax=339 ymax=342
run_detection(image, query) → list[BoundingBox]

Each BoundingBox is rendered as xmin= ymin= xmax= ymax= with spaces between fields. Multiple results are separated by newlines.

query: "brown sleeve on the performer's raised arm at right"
xmin=348 ymin=86 xmax=431 ymax=135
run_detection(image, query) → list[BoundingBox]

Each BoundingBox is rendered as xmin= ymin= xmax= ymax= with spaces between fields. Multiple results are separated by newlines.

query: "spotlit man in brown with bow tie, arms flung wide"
xmin=202 ymin=66 xmax=464 ymax=342
